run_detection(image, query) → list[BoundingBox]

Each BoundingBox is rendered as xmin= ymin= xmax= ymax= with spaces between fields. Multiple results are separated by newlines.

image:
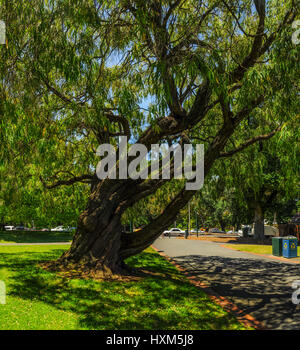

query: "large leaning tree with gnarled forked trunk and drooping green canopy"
xmin=0 ymin=0 xmax=299 ymax=275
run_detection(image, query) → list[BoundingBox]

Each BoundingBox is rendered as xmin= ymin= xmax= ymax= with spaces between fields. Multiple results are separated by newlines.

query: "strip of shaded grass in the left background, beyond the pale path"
xmin=0 ymin=231 xmax=73 ymax=243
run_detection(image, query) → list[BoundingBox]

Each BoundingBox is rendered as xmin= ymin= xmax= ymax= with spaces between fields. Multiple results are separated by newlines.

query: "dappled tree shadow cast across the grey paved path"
xmin=175 ymin=255 xmax=300 ymax=329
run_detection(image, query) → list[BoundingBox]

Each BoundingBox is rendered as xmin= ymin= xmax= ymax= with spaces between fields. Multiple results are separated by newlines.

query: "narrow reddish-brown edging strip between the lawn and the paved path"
xmin=151 ymin=245 xmax=266 ymax=330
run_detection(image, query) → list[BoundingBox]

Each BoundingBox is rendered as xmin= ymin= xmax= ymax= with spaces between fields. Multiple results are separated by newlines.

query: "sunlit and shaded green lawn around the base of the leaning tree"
xmin=0 ymin=245 xmax=245 ymax=330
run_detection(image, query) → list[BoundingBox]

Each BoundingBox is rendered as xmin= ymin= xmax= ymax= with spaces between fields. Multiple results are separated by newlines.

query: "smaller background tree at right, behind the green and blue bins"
xmin=216 ymin=117 xmax=300 ymax=240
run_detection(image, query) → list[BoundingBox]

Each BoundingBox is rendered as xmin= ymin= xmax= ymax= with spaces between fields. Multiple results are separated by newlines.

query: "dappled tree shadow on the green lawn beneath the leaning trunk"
xmin=0 ymin=249 xmax=243 ymax=329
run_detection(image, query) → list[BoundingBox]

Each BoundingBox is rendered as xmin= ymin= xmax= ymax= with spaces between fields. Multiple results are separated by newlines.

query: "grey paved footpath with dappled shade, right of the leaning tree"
xmin=153 ymin=238 xmax=300 ymax=330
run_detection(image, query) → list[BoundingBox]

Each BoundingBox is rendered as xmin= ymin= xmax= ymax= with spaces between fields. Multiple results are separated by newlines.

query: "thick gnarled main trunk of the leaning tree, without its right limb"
xmin=44 ymin=180 xmax=135 ymax=278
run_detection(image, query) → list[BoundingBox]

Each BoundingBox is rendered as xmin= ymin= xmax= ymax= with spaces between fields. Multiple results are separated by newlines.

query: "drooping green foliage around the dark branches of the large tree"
xmin=0 ymin=0 xmax=299 ymax=225
